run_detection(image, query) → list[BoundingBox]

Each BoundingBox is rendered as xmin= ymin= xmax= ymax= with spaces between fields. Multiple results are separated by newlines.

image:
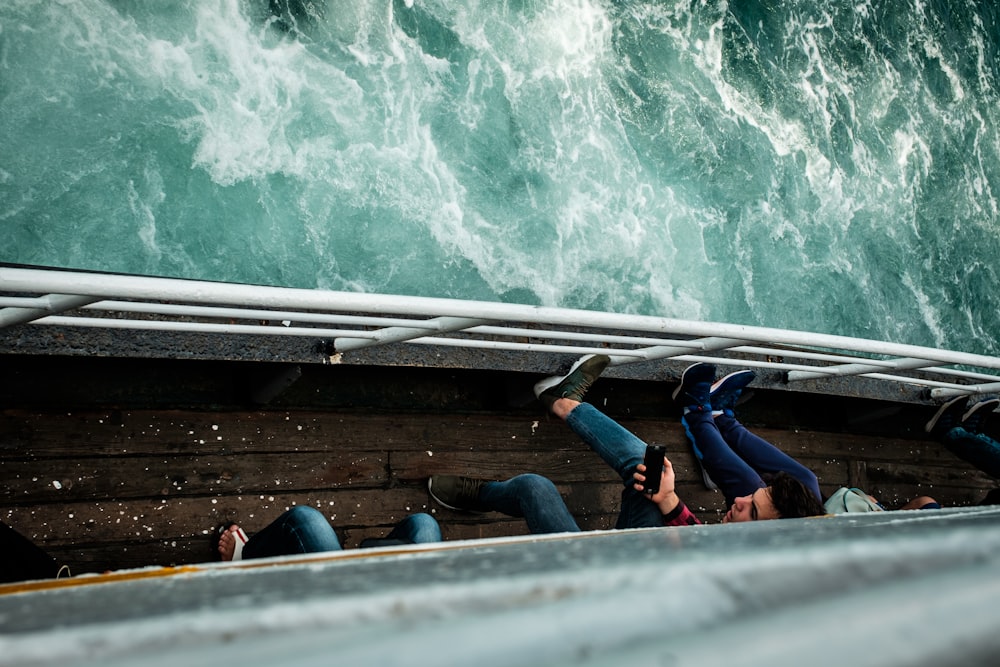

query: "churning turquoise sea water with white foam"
xmin=0 ymin=0 xmax=1000 ymax=354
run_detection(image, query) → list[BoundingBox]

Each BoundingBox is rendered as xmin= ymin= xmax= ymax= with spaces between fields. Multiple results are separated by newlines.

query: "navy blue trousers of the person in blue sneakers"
xmin=682 ymin=411 xmax=823 ymax=505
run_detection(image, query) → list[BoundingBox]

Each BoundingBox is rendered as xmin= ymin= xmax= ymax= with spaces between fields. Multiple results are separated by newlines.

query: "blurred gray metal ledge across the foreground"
xmin=0 ymin=507 xmax=1000 ymax=667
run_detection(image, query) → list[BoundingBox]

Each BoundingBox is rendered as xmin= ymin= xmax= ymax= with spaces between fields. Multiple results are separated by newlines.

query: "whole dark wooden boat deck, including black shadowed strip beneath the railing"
xmin=0 ymin=355 xmax=996 ymax=574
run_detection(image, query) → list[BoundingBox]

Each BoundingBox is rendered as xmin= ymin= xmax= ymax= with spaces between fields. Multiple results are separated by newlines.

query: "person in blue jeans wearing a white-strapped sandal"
xmin=218 ymin=505 xmax=441 ymax=561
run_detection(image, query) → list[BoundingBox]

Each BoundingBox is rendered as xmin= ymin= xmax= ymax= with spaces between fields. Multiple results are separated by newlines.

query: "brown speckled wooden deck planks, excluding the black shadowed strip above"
xmin=0 ymin=360 xmax=995 ymax=573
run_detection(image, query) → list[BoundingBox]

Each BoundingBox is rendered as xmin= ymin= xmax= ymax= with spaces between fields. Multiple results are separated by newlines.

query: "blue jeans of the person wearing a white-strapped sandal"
xmin=243 ymin=506 xmax=441 ymax=559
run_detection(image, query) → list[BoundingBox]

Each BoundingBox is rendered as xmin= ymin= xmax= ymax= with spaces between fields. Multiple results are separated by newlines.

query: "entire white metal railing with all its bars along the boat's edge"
xmin=0 ymin=266 xmax=1000 ymax=399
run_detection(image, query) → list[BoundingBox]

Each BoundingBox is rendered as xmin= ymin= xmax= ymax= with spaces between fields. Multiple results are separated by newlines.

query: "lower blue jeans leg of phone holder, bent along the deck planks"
xmin=479 ymin=473 xmax=580 ymax=535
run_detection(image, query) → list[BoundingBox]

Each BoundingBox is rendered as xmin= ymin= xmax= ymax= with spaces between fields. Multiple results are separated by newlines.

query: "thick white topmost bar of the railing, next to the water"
xmin=0 ymin=267 xmax=1000 ymax=369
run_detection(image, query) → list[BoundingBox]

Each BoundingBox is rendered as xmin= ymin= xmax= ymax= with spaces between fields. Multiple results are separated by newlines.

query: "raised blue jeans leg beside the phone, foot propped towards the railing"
xmin=566 ymin=403 xmax=663 ymax=528
